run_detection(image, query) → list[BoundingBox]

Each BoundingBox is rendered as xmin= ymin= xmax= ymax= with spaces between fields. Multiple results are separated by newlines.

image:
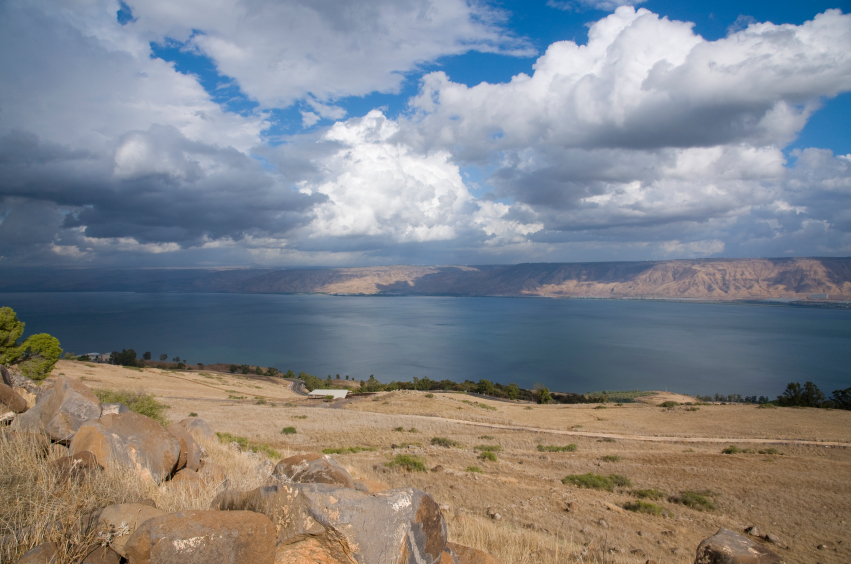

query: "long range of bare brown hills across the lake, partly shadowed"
xmin=0 ymin=258 xmax=851 ymax=301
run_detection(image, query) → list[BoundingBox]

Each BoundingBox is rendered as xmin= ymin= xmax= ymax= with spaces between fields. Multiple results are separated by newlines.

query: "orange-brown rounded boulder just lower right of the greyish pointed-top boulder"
xmin=70 ymin=413 xmax=180 ymax=483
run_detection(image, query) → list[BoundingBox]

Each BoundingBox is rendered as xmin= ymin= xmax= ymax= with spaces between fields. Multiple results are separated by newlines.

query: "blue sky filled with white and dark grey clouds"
xmin=0 ymin=0 xmax=851 ymax=268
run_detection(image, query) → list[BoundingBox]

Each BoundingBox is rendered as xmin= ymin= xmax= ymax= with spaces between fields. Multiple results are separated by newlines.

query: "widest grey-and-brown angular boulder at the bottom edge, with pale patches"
xmin=212 ymin=484 xmax=447 ymax=564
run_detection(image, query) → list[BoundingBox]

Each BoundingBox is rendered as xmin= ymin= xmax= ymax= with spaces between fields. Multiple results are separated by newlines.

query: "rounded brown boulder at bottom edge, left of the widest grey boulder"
xmin=124 ymin=510 xmax=275 ymax=564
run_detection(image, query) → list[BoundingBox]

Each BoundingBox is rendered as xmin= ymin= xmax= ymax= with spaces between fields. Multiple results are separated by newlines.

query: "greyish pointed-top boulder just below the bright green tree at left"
xmin=12 ymin=376 xmax=101 ymax=443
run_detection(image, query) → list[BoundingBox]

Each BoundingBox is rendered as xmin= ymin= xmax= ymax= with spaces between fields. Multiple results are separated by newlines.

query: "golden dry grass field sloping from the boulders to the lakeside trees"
xmin=15 ymin=361 xmax=851 ymax=564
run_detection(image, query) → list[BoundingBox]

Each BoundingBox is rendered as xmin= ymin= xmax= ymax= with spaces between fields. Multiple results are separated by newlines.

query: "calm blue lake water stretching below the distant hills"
xmin=0 ymin=293 xmax=851 ymax=397
